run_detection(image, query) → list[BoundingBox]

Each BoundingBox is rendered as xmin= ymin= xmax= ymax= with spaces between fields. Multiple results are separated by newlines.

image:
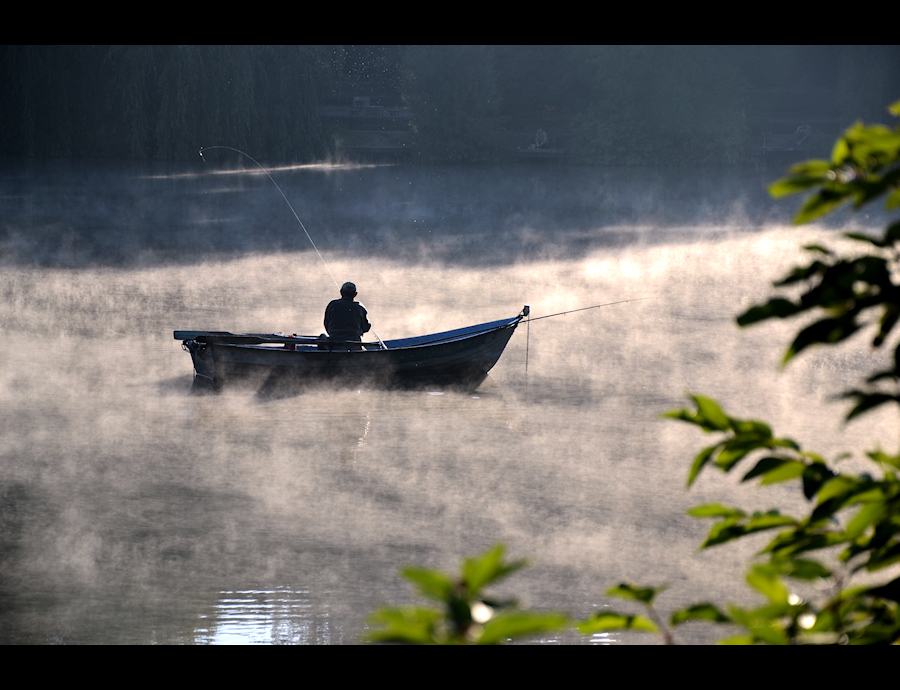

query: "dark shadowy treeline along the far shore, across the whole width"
xmin=0 ymin=46 xmax=900 ymax=165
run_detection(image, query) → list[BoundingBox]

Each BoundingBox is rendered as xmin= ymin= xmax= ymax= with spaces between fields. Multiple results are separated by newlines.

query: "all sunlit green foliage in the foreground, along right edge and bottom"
xmin=366 ymin=101 xmax=900 ymax=644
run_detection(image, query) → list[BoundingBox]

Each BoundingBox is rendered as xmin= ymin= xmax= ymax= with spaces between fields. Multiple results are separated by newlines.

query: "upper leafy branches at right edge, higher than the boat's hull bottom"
xmin=737 ymin=101 xmax=900 ymax=419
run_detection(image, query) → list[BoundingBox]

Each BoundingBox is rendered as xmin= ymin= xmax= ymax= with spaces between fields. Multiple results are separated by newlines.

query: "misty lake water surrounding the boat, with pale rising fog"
xmin=0 ymin=159 xmax=896 ymax=644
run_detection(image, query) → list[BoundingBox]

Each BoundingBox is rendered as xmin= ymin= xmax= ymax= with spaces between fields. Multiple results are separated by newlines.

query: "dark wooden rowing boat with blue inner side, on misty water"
xmin=175 ymin=306 xmax=529 ymax=392
